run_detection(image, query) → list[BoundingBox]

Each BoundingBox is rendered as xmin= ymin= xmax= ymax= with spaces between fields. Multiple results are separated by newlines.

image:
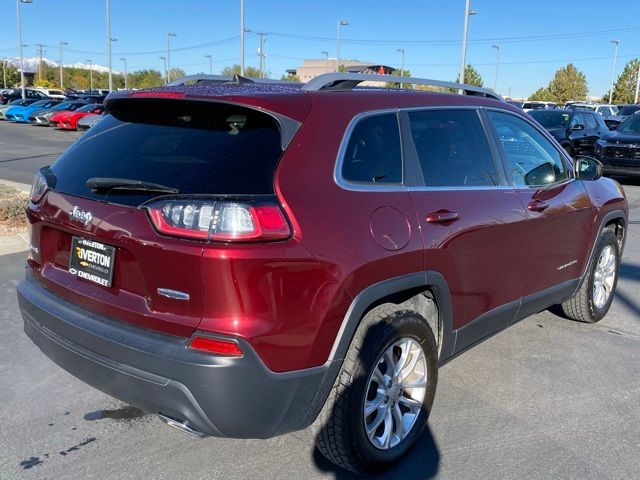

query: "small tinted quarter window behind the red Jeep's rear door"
xmin=342 ymin=113 xmax=402 ymax=184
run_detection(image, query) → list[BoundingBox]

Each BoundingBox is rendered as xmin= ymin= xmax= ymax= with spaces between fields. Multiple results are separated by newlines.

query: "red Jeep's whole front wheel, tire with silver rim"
xmin=562 ymin=228 xmax=620 ymax=323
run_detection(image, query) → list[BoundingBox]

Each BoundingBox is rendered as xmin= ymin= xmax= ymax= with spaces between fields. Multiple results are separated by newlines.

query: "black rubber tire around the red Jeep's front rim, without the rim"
xmin=561 ymin=228 xmax=620 ymax=323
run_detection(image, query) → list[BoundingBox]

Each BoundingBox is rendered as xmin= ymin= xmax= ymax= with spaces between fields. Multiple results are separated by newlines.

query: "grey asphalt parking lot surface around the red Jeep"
xmin=0 ymin=123 xmax=640 ymax=480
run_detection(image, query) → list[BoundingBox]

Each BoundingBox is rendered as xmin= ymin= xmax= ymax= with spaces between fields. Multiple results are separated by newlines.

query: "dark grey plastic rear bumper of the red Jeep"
xmin=18 ymin=272 xmax=339 ymax=438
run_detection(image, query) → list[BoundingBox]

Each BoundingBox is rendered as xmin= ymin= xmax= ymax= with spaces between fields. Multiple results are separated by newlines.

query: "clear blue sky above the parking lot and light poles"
xmin=0 ymin=0 xmax=640 ymax=96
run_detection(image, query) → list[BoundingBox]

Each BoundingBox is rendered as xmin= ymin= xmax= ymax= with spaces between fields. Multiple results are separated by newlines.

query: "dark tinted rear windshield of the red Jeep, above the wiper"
xmin=51 ymin=99 xmax=282 ymax=205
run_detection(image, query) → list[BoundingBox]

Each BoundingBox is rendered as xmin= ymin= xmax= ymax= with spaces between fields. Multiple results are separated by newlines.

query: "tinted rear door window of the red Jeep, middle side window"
xmin=409 ymin=110 xmax=498 ymax=187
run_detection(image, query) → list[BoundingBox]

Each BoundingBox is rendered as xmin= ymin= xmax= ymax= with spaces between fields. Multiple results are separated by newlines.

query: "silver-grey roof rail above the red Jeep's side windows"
xmin=302 ymin=73 xmax=504 ymax=101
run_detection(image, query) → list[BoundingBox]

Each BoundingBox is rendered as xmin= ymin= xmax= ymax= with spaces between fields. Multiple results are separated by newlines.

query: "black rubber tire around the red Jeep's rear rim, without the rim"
xmin=311 ymin=305 xmax=438 ymax=474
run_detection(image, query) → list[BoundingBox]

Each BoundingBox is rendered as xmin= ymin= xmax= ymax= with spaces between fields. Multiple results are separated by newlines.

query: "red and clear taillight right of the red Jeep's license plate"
xmin=147 ymin=198 xmax=291 ymax=242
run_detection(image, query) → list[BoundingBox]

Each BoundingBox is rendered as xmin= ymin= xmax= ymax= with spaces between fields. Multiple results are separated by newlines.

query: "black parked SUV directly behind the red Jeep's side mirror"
xmin=529 ymin=108 xmax=609 ymax=156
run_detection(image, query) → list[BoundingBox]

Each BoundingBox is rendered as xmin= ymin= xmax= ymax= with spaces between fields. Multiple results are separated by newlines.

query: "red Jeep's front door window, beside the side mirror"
xmin=489 ymin=112 xmax=569 ymax=186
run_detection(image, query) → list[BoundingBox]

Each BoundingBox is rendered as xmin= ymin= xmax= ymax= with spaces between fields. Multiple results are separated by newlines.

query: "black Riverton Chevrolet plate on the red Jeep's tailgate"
xmin=69 ymin=237 xmax=116 ymax=287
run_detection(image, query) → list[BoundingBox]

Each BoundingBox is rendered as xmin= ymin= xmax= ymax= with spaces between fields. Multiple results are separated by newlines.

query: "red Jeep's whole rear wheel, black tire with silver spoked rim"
xmin=313 ymin=306 xmax=438 ymax=473
